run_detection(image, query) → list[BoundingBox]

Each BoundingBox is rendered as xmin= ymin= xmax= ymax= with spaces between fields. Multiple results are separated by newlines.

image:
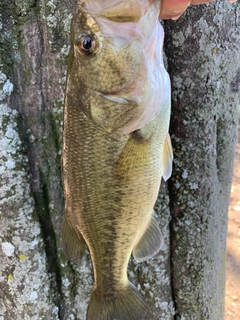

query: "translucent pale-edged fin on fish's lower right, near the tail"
xmin=133 ymin=212 xmax=163 ymax=262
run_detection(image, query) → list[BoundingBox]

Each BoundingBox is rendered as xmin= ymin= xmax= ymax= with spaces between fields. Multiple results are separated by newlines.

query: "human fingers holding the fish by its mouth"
xmin=160 ymin=0 xmax=237 ymax=20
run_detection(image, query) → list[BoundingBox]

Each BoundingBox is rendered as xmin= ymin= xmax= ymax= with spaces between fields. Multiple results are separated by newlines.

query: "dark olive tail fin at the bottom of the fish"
xmin=87 ymin=283 xmax=149 ymax=320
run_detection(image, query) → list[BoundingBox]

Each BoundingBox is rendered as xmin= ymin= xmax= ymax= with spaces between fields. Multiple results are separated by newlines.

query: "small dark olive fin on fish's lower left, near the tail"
xmin=62 ymin=214 xmax=86 ymax=262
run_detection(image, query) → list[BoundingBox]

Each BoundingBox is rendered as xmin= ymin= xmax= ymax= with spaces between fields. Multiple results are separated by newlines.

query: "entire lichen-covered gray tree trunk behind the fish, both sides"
xmin=0 ymin=0 xmax=240 ymax=320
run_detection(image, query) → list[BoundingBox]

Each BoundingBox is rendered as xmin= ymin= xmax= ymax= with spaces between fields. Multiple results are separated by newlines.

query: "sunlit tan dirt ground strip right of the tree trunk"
xmin=225 ymin=125 xmax=240 ymax=320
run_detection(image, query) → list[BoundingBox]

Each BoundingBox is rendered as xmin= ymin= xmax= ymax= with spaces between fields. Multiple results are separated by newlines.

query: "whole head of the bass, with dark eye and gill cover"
xmin=67 ymin=0 xmax=169 ymax=134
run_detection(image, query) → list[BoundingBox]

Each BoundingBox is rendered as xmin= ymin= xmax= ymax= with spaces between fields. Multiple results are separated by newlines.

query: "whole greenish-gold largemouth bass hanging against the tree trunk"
xmin=62 ymin=0 xmax=173 ymax=320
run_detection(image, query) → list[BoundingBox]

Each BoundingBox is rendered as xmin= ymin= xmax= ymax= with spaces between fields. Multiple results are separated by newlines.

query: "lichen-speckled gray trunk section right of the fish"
xmin=165 ymin=1 xmax=240 ymax=320
